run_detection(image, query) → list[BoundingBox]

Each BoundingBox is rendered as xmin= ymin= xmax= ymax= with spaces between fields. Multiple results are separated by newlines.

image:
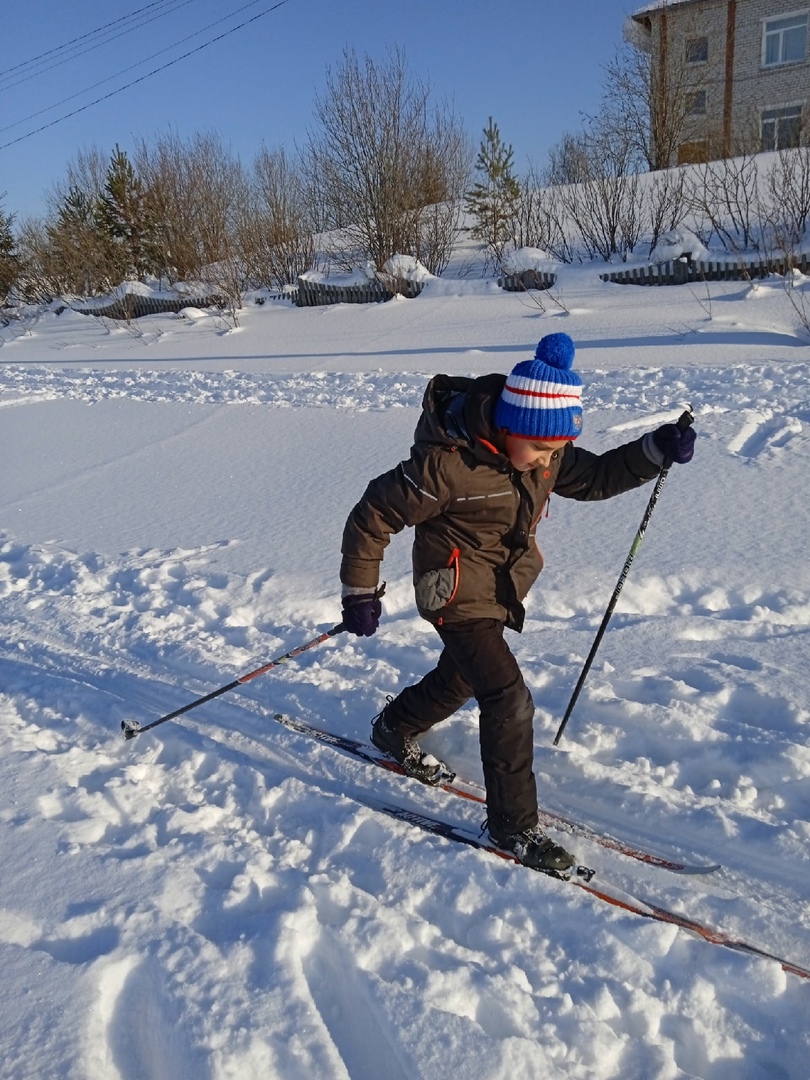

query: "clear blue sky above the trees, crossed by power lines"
xmin=0 ymin=0 xmax=642 ymax=219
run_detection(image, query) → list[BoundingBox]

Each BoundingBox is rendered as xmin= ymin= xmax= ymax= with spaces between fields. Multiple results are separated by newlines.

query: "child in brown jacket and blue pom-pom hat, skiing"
xmin=340 ymin=334 xmax=694 ymax=873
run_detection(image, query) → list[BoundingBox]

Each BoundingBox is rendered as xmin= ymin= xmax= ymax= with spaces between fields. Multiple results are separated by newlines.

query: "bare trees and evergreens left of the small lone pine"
xmin=0 ymin=50 xmax=472 ymax=311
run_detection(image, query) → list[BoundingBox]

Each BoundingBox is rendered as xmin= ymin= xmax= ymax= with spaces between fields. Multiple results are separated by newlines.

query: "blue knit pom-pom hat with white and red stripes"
xmin=495 ymin=334 xmax=582 ymax=440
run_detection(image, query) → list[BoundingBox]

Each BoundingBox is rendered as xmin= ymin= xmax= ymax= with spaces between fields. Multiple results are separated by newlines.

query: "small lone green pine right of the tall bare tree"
xmin=464 ymin=117 xmax=521 ymax=267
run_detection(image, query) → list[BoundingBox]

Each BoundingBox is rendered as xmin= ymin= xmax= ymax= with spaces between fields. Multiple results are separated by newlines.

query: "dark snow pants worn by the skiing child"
xmin=386 ymin=619 xmax=537 ymax=838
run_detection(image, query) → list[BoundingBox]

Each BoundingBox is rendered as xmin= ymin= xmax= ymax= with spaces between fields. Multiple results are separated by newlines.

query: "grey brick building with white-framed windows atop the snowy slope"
xmin=631 ymin=0 xmax=810 ymax=166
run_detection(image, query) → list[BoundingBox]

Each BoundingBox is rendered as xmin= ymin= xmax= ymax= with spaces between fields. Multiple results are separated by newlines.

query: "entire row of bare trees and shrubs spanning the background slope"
xmin=0 ymin=45 xmax=810 ymax=307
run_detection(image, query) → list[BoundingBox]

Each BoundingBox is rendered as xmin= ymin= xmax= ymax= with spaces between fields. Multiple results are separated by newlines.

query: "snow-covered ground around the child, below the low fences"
xmin=0 ymin=266 xmax=810 ymax=1080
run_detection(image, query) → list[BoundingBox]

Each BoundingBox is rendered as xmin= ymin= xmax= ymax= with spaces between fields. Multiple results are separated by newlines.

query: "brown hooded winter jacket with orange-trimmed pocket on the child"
xmin=340 ymin=375 xmax=658 ymax=631
